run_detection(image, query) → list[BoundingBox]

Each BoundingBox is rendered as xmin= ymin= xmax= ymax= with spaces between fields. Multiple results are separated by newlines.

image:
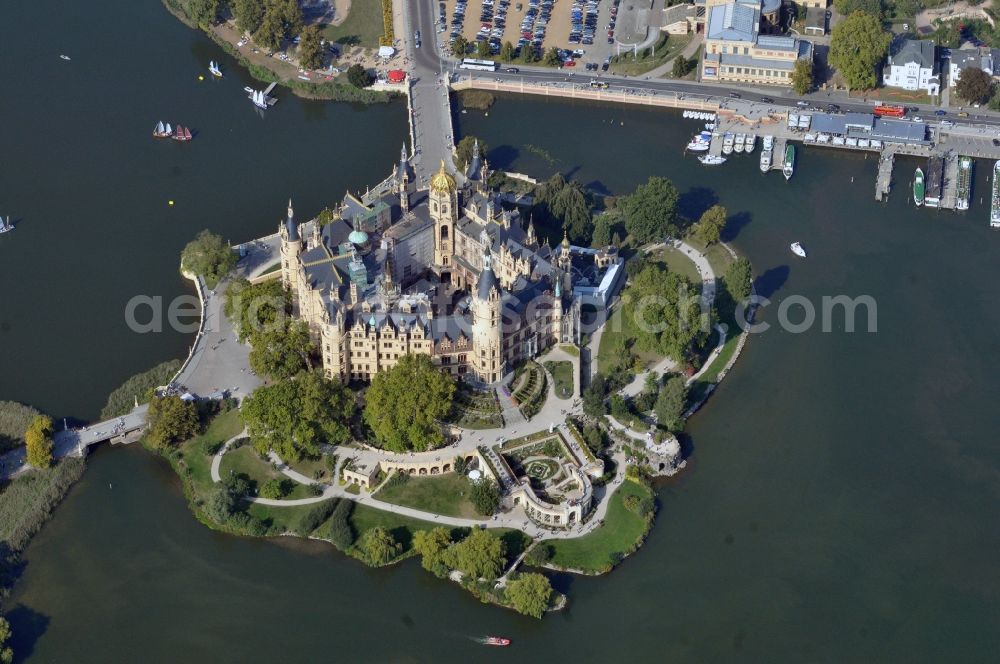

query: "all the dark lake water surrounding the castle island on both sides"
xmin=0 ymin=1 xmax=1000 ymax=663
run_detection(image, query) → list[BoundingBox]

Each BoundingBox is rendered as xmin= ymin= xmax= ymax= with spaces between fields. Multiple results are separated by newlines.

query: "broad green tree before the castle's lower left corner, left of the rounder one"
xmin=242 ymin=371 xmax=354 ymax=461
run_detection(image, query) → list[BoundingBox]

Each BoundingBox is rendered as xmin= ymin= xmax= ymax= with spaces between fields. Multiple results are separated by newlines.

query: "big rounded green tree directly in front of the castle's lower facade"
xmin=364 ymin=354 xmax=455 ymax=452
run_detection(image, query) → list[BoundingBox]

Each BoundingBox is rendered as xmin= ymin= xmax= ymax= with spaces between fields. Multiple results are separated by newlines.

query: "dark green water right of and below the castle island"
xmin=0 ymin=2 xmax=1000 ymax=663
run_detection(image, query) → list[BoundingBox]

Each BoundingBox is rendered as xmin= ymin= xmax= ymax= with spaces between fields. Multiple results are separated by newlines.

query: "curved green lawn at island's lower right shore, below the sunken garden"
xmin=546 ymin=480 xmax=652 ymax=572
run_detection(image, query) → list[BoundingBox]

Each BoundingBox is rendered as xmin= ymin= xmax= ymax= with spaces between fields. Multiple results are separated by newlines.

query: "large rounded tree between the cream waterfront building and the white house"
xmin=828 ymin=11 xmax=892 ymax=90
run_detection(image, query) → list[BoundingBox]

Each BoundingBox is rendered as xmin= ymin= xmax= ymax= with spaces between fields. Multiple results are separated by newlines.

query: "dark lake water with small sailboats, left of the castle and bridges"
xmin=0 ymin=0 xmax=408 ymax=418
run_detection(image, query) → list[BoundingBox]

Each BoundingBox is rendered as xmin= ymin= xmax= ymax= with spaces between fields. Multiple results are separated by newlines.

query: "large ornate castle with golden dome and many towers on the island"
xmin=279 ymin=147 xmax=622 ymax=384
